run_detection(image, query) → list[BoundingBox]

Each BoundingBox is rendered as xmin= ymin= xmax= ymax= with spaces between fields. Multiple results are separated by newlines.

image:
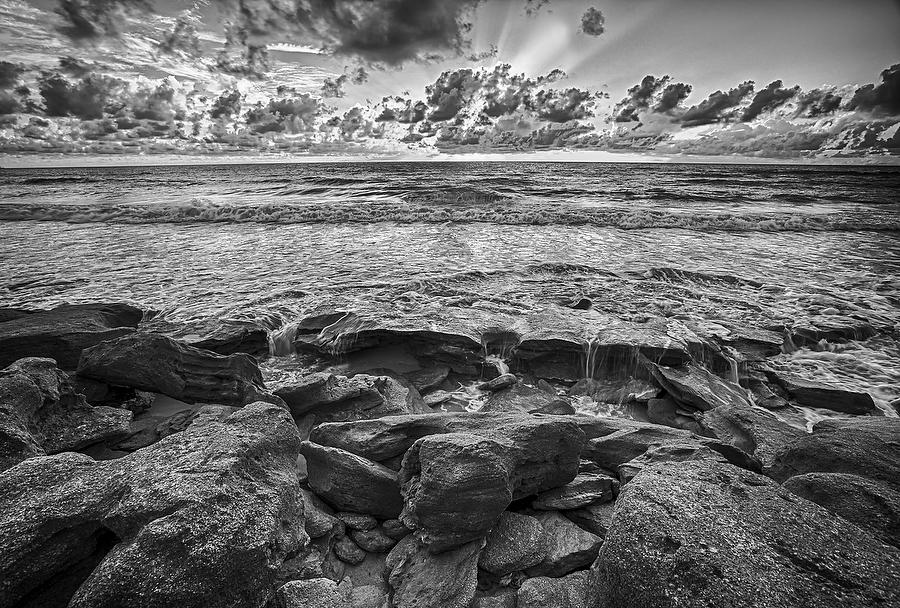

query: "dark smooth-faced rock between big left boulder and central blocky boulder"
xmin=301 ymin=441 xmax=403 ymax=518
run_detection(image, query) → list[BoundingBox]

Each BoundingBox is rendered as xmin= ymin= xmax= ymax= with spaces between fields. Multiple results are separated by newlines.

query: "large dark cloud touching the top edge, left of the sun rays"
xmin=218 ymin=0 xmax=478 ymax=65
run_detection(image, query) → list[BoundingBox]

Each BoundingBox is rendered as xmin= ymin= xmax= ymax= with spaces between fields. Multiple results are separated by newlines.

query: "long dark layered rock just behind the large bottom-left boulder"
xmin=78 ymin=333 xmax=273 ymax=406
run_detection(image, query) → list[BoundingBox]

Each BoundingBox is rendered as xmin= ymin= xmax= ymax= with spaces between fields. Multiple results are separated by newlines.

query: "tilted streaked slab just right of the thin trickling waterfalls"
xmin=651 ymin=363 xmax=751 ymax=411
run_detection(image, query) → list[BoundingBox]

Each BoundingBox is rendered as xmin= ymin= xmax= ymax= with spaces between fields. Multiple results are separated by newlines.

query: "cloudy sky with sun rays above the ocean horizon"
xmin=0 ymin=0 xmax=900 ymax=166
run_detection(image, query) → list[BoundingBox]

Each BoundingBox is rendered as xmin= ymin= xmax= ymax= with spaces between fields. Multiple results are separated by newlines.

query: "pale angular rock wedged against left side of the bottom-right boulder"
xmin=526 ymin=511 xmax=603 ymax=577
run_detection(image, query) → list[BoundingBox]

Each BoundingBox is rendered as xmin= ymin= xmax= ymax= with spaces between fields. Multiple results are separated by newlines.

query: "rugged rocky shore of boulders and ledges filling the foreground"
xmin=0 ymin=304 xmax=900 ymax=608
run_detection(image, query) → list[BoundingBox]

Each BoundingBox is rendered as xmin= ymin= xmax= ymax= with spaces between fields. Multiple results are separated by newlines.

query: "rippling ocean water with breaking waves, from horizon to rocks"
xmin=0 ymin=163 xmax=900 ymax=414
